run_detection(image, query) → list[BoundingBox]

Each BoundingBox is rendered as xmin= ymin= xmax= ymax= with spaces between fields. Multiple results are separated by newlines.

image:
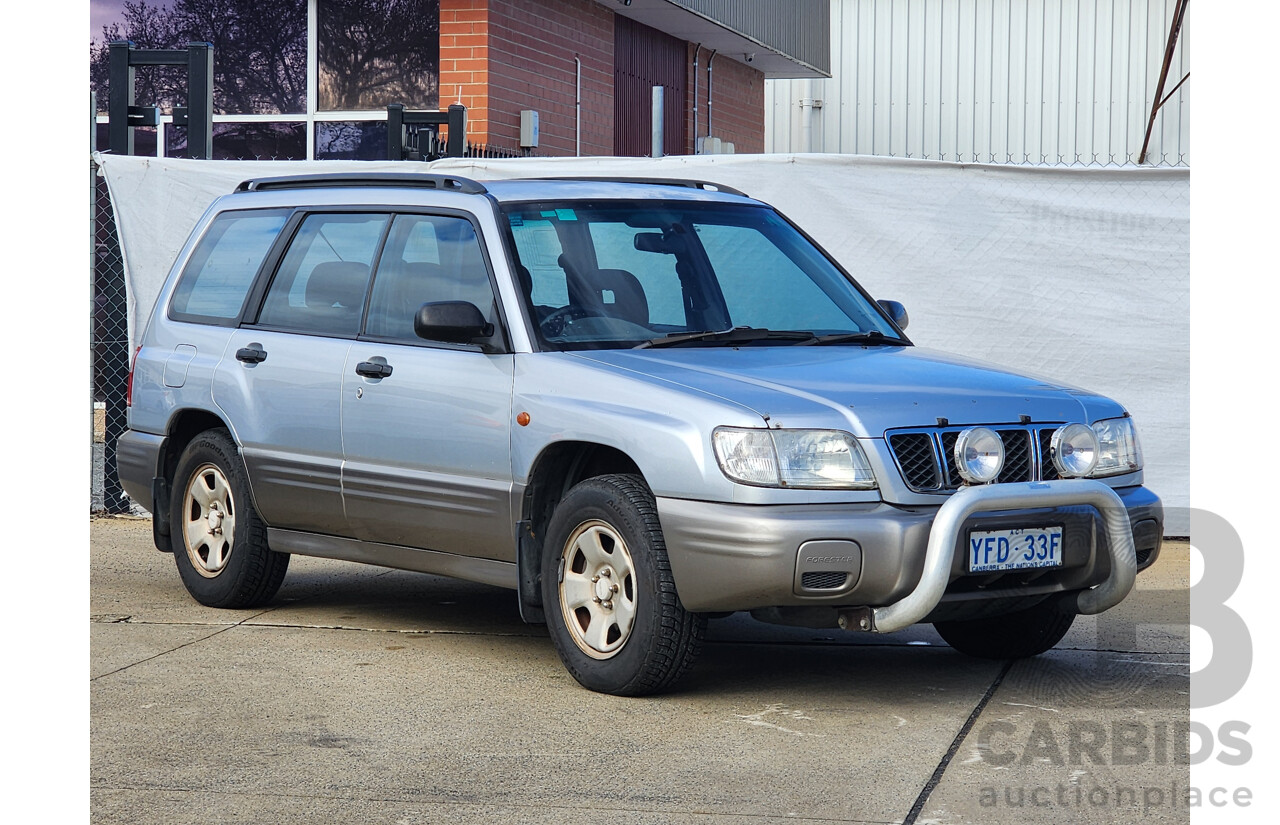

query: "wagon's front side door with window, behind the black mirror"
xmin=340 ymin=212 xmax=515 ymax=562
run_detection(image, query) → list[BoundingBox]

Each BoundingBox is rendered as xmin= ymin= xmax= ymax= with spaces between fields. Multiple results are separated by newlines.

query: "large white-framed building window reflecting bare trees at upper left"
xmin=90 ymin=0 xmax=440 ymax=160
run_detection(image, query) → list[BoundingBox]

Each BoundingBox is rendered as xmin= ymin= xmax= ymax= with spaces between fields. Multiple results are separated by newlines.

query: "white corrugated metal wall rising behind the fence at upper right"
xmin=764 ymin=0 xmax=1192 ymax=166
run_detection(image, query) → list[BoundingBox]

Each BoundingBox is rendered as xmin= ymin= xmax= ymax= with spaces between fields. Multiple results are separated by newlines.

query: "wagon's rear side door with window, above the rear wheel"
xmin=214 ymin=212 xmax=390 ymax=536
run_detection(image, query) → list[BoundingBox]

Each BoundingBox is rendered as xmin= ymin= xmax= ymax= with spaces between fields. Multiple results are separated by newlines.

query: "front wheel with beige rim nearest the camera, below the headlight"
xmin=541 ymin=475 xmax=707 ymax=696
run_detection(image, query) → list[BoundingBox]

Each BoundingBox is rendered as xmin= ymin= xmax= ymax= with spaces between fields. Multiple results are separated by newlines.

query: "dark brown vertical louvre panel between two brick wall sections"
xmin=613 ymin=14 xmax=689 ymax=157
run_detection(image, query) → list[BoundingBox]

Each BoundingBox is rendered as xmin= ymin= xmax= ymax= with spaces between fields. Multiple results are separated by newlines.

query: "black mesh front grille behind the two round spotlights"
xmin=888 ymin=425 xmax=1059 ymax=492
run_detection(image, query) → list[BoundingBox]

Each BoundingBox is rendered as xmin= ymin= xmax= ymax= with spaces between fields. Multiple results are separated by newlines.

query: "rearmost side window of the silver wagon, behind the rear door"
xmin=169 ymin=210 xmax=289 ymax=325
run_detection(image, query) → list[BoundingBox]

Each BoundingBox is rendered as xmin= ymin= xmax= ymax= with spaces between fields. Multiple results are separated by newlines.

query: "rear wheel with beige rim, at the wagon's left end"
xmin=169 ymin=430 xmax=289 ymax=608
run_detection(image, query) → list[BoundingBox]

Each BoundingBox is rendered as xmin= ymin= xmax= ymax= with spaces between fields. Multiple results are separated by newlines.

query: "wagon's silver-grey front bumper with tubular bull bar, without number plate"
xmin=658 ymin=480 xmax=1164 ymax=619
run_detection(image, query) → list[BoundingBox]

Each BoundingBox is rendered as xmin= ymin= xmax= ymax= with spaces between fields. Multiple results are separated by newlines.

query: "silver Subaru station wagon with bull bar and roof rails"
xmin=118 ymin=174 xmax=1164 ymax=696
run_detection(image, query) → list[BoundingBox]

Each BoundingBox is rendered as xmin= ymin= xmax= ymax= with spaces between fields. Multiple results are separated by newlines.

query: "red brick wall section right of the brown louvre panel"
xmin=686 ymin=43 xmax=764 ymax=155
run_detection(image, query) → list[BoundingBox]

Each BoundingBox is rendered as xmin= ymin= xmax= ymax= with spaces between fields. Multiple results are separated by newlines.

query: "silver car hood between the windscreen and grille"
xmin=573 ymin=345 xmax=1124 ymax=437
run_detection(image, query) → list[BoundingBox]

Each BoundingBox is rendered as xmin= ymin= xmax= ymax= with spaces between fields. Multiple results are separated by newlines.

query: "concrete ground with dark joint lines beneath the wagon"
xmin=90 ymin=518 xmax=1190 ymax=825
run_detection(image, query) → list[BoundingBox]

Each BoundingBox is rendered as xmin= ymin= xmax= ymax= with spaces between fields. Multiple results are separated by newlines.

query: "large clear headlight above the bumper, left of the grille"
xmin=712 ymin=427 xmax=876 ymax=490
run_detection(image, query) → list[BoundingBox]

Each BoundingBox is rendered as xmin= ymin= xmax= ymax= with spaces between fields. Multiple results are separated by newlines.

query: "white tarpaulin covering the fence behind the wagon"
xmin=97 ymin=155 xmax=1190 ymax=535
